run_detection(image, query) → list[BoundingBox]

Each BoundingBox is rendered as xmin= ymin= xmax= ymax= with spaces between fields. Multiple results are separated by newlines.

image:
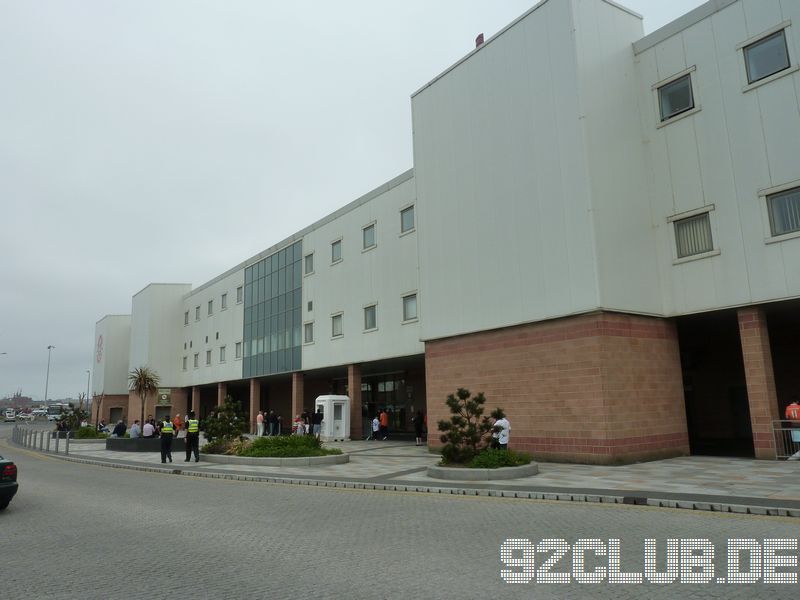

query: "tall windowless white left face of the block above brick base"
xmin=412 ymin=0 xmax=598 ymax=339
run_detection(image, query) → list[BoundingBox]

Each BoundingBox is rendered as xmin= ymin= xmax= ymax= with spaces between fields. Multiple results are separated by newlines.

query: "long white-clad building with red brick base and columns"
xmin=95 ymin=0 xmax=800 ymax=463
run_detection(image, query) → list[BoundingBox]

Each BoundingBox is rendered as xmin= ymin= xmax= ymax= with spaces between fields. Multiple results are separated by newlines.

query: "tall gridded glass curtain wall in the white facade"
xmin=242 ymin=241 xmax=303 ymax=377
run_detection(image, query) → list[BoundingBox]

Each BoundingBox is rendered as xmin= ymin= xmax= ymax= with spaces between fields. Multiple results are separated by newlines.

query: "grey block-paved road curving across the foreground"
xmin=0 ymin=424 xmax=800 ymax=600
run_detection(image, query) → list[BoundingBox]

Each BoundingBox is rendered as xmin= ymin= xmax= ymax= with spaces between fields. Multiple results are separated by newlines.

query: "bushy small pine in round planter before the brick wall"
xmin=438 ymin=388 xmax=504 ymax=464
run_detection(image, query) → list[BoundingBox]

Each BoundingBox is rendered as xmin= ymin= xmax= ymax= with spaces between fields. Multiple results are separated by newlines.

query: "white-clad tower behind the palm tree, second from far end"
xmin=128 ymin=283 xmax=191 ymax=387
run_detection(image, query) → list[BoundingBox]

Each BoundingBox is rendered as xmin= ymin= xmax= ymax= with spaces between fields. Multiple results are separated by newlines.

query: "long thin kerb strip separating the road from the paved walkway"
xmin=40 ymin=453 xmax=800 ymax=518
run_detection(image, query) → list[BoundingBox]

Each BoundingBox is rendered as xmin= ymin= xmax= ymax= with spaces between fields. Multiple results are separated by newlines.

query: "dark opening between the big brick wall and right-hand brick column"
xmin=677 ymin=311 xmax=755 ymax=457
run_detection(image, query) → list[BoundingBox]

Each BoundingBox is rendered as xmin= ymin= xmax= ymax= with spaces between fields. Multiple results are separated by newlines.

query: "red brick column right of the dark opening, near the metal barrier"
xmin=738 ymin=307 xmax=780 ymax=458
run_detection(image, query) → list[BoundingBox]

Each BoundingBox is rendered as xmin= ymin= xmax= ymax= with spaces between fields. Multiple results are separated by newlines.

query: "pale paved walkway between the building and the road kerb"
xmin=34 ymin=441 xmax=800 ymax=517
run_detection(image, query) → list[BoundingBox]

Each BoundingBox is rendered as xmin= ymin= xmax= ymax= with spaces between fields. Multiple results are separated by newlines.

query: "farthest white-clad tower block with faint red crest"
xmin=91 ymin=315 xmax=131 ymax=396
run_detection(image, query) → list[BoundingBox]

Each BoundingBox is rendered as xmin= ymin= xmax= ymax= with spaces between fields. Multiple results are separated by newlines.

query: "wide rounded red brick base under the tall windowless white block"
xmin=425 ymin=313 xmax=689 ymax=464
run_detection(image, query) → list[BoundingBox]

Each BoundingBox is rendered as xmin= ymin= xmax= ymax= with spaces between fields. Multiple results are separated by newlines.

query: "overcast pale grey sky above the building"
xmin=0 ymin=0 xmax=702 ymax=400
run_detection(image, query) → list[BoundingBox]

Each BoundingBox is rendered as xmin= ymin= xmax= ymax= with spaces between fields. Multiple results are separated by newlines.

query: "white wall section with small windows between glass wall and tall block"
xmin=302 ymin=178 xmax=426 ymax=370
